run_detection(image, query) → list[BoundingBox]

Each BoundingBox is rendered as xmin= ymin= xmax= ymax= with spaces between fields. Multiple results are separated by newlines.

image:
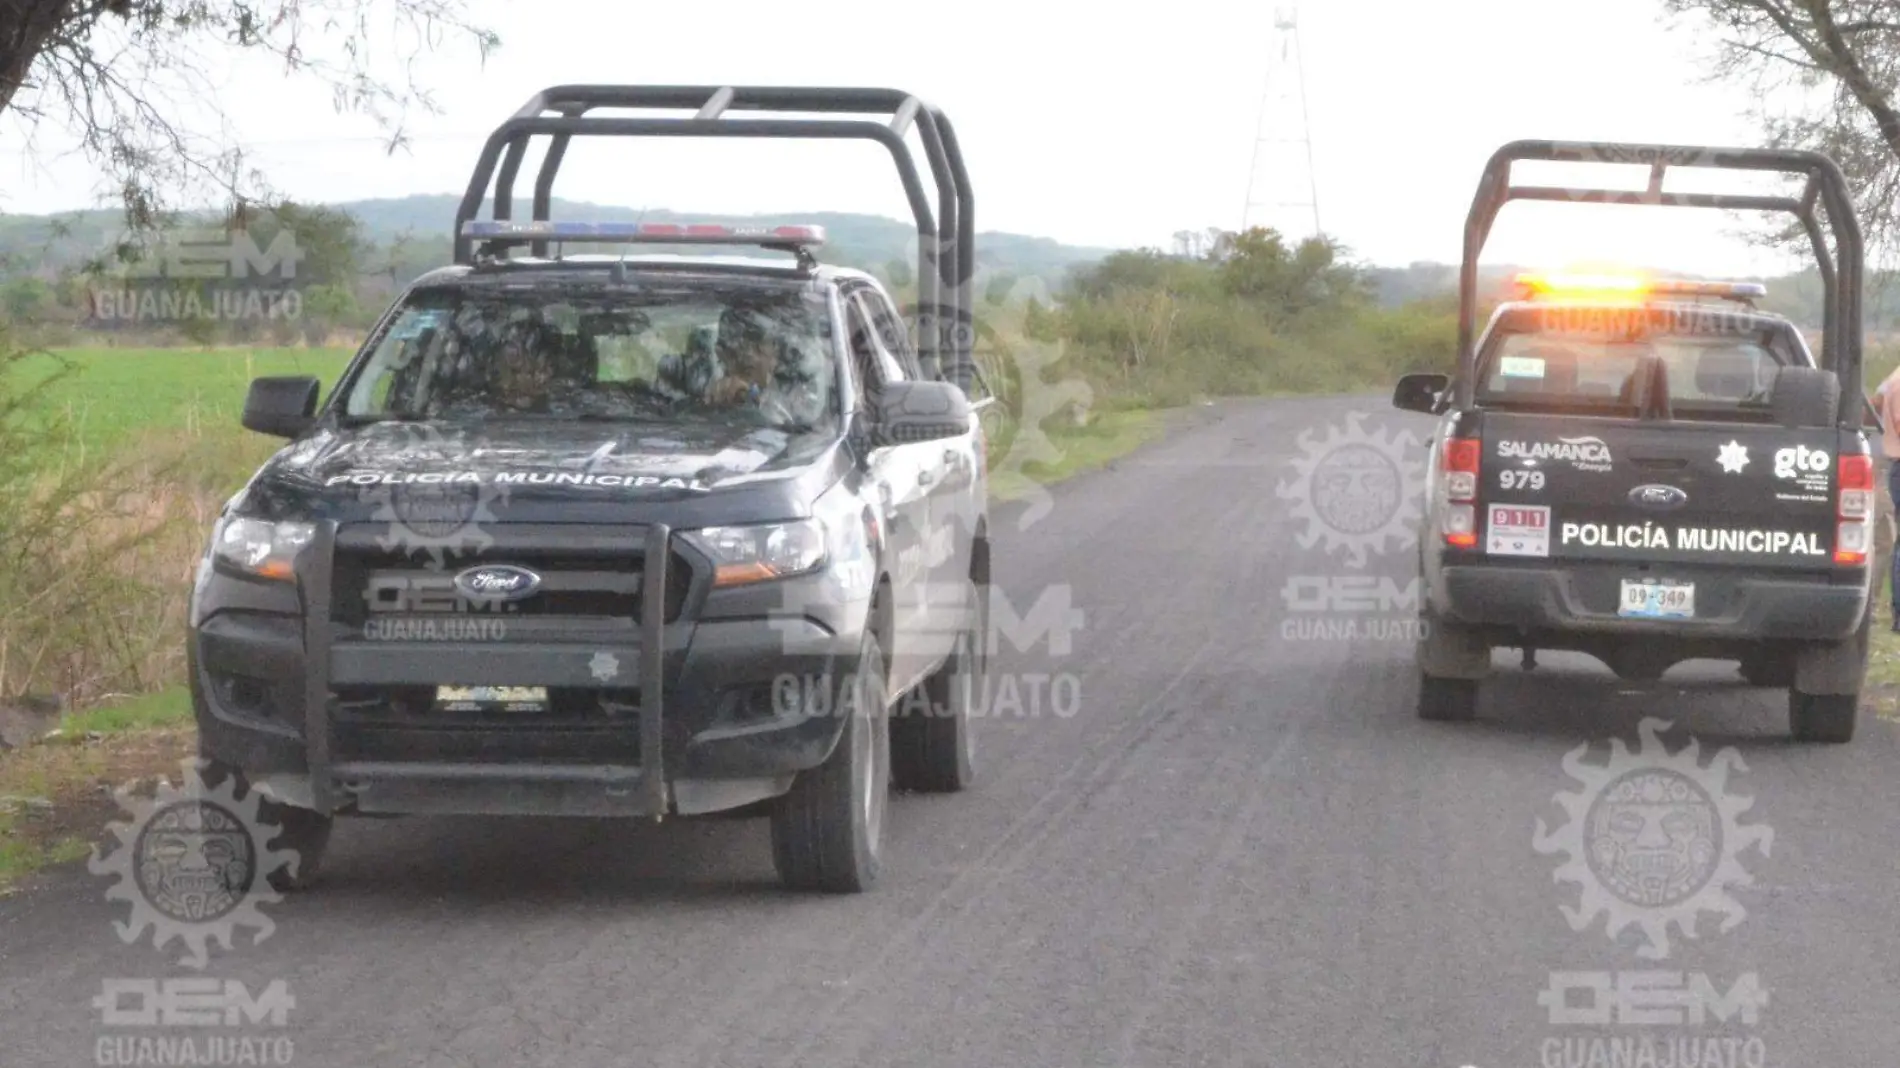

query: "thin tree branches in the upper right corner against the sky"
xmin=1663 ymin=0 xmax=1900 ymax=251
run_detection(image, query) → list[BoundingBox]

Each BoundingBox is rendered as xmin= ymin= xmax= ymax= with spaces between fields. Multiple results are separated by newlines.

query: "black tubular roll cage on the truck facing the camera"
xmin=454 ymin=86 xmax=977 ymax=391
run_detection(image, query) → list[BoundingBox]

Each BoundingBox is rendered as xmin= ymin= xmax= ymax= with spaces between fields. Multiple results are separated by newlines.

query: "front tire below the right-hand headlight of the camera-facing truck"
xmin=771 ymin=630 xmax=891 ymax=893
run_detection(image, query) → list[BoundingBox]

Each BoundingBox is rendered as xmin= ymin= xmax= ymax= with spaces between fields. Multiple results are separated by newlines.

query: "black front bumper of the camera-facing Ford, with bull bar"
xmin=188 ymin=524 xmax=868 ymax=815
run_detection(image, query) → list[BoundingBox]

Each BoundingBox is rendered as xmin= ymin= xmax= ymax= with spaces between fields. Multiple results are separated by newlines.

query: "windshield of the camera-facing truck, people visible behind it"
xmin=344 ymin=283 xmax=838 ymax=429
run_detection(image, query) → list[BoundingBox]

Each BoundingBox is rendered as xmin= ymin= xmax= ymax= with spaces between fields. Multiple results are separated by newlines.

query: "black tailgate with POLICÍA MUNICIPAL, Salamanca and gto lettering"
xmin=1478 ymin=412 xmax=1839 ymax=570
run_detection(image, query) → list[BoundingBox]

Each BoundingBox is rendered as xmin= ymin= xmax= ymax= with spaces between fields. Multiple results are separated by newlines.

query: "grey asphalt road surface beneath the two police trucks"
xmin=0 ymin=397 xmax=1900 ymax=1068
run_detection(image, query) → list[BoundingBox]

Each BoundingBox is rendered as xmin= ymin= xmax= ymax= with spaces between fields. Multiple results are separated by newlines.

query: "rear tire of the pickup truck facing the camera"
xmin=891 ymin=582 xmax=990 ymax=794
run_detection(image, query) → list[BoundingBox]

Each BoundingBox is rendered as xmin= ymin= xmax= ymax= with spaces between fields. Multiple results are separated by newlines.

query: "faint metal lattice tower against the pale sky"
xmin=1241 ymin=4 xmax=1322 ymax=241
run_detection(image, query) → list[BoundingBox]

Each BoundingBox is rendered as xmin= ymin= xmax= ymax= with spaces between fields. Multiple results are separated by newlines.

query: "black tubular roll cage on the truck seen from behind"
xmin=1455 ymin=141 xmax=1866 ymax=426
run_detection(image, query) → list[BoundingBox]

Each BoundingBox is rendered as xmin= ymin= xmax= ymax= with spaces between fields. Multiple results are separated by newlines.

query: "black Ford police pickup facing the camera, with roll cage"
xmin=188 ymin=86 xmax=990 ymax=891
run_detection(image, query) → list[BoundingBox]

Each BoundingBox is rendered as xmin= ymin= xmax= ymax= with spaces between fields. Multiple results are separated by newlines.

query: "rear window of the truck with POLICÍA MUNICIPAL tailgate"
xmin=1478 ymin=317 xmax=1784 ymax=414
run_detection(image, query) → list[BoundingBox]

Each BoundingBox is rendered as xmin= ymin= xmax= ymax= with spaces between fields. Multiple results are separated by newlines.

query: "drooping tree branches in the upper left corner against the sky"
xmin=0 ymin=0 xmax=500 ymax=234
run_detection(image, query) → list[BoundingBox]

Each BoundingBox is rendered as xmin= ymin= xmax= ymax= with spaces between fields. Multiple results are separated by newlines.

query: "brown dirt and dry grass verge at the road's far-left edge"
xmin=0 ymin=730 xmax=196 ymax=893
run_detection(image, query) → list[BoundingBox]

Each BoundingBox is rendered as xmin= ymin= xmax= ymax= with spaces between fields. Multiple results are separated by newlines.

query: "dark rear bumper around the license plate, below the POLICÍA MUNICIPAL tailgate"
xmin=1433 ymin=564 xmax=1870 ymax=642
